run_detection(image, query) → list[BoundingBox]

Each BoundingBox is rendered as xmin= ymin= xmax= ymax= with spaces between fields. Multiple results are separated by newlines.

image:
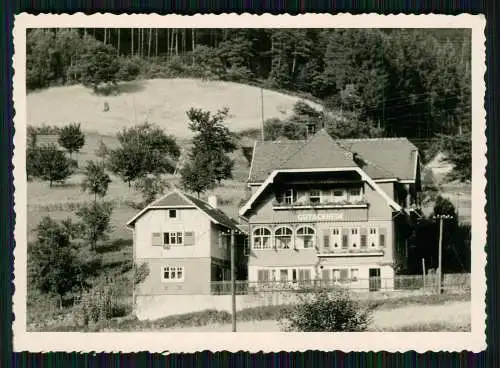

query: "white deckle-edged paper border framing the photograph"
xmin=13 ymin=13 xmax=487 ymax=352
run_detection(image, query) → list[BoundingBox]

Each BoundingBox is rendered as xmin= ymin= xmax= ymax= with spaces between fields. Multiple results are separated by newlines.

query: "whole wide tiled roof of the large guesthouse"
xmin=248 ymin=130 xmax=418 ymax=183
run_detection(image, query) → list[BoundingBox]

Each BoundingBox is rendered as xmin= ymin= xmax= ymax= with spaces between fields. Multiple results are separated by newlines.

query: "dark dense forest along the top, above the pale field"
xmin=27 ymin=28 xmax=471 ymax=140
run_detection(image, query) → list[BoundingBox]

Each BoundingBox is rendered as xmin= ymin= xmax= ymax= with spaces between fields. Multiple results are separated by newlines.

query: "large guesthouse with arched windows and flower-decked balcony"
xmin=239 ymin=130 xmax=420 ymax=290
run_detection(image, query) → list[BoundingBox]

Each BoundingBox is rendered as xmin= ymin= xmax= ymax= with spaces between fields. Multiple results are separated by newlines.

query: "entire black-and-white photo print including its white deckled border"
xmin=14 ymin=14 xmax=486 ymax=351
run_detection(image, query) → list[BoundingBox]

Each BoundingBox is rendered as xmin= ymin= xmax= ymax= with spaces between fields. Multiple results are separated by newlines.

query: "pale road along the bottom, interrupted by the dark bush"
xmin=158 ymin=301 xmax=471 ymax=332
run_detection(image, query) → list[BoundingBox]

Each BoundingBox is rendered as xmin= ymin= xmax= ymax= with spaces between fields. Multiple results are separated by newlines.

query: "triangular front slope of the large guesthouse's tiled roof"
xmin=279 ymin=129 xmax=357 ymax=169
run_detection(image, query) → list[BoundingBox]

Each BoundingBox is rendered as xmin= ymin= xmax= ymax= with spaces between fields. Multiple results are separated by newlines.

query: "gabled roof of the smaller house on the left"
xmin=127 ymin=189 xmax=240 ymax=231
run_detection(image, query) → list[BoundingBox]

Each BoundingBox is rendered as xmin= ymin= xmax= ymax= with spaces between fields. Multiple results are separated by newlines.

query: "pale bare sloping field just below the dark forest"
xmin=27 ymin=79 xmax=319 ymax=137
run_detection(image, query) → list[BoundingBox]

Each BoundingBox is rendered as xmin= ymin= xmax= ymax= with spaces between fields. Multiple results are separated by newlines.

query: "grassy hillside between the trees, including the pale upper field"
xmin=26 ymin=79 xmax=304 ymax=326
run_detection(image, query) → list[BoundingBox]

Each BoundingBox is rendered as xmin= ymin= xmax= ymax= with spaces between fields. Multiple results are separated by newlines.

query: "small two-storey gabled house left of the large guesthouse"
xmin=127 ymin=190 xmax=246 ymax=300
